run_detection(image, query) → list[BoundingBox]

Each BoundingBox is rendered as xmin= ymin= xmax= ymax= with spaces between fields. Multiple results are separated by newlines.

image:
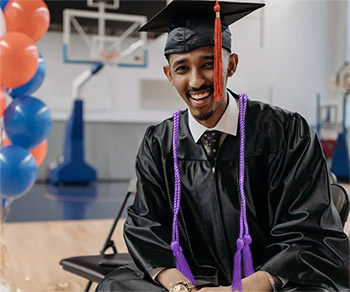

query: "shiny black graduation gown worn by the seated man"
xmin=124 ymin=100 xmax=349 ymax=290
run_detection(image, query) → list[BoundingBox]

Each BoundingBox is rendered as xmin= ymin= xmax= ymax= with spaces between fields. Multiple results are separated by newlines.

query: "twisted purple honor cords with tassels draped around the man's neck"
xmin=171 ymin=94 xmax=254 ymax=291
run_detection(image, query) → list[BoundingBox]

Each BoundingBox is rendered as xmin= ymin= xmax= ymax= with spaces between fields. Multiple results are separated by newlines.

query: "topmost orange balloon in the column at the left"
xmin=4 ymin=0 xmax=50 ymax=43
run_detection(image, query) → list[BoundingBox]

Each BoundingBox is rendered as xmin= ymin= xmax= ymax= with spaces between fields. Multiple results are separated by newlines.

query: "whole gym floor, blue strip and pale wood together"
xmin=0 ymin=181 xmax=350 ymax=292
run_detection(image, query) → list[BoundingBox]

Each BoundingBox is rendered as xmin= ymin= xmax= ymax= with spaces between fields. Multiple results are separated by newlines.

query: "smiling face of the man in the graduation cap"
xmin=164 ymin=47 xmax=238 ymax=127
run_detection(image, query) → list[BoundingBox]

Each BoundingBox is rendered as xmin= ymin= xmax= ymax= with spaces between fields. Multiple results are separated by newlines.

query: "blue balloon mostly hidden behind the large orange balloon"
xmin=9 ymin=55 xmax=46 ymax=98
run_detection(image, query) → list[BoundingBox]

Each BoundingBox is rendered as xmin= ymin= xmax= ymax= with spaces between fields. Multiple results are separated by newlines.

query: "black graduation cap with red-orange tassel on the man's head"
xmin=139 ymin=0 xmax=265 ymax=100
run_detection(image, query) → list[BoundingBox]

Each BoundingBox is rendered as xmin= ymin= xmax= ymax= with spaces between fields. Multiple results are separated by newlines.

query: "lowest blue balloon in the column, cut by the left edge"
xmin=0 ymin=145 xmax=37 ymax=198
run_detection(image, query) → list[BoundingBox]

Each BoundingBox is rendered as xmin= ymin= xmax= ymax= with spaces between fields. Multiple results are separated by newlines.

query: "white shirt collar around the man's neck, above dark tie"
xmin=188 ymin=93 xmax=238 ymax=143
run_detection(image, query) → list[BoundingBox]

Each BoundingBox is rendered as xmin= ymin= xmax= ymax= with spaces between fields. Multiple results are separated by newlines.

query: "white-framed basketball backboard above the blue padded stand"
xmin=62 ymin=0 xmax=147 ymax=67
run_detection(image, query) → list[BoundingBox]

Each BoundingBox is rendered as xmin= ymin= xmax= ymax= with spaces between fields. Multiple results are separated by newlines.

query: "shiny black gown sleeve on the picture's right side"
xmin=260 ymin=114 xmax=349 ymax=291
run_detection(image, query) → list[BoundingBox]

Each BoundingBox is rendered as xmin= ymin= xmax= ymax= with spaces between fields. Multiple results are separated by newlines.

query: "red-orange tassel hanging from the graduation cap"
xmin=214 ymin=0 xmax=223 ymax=101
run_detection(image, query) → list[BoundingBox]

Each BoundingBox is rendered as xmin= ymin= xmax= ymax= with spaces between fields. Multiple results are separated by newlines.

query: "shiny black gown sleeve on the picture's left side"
xmin=124 ymin=127 xmax=176 ymax=274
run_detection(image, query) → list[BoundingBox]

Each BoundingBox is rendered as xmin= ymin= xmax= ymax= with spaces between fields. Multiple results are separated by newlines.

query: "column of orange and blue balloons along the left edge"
xmin=0 ymin=0 xmax=51 ymax=208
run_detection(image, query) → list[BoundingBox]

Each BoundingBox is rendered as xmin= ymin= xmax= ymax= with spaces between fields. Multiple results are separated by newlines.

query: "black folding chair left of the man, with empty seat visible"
xmin=60 ymin=178 xmax=136 ymax=291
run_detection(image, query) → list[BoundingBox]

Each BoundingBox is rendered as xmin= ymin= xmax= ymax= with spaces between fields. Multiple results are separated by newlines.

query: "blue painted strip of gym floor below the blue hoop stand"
xmin=6 ymin=180 xmax=128 ymax=222
